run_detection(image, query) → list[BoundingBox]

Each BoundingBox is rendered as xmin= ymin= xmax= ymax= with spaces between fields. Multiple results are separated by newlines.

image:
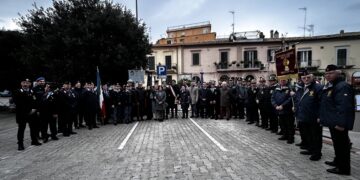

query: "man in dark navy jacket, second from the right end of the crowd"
xmin=295 ymin=71 xmax=323 ymax=161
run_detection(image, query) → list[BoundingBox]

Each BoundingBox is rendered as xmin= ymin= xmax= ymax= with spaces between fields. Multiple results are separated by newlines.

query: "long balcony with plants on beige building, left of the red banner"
xmin=214 ymin=61 xmax=265 ymax=72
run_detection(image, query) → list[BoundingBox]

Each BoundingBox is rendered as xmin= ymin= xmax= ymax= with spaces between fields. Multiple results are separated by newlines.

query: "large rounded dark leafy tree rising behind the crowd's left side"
xmin=18 ymin=0 xmax=151 ymax=82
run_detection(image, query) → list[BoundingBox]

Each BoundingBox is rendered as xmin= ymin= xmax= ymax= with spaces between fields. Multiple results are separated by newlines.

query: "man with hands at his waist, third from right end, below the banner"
xmin=271 ymin=79 xmax=295 ymax=144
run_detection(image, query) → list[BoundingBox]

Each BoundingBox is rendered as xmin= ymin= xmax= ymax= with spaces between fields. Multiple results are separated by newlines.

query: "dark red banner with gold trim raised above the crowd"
xmin=275 ymin=48 xmax=299 ymax=79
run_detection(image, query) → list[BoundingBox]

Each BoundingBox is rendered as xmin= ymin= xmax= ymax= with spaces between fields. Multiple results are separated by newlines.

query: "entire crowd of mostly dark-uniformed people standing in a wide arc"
xmin=13 ymin=65 xmax=354 ymax=175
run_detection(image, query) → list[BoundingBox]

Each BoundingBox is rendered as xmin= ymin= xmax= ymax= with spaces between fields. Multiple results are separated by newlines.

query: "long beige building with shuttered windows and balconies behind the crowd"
xmin=150 ymin=26 xmax=360 ymax=86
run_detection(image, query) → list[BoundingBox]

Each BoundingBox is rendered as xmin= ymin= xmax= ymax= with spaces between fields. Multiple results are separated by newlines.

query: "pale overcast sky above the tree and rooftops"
xmin=0 ymin=0 xmax=360 ymax=42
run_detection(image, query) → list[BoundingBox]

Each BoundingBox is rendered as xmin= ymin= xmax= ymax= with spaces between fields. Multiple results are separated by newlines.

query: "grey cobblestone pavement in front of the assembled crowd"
xmin=0 ymin=114 xmax=360 ymax=180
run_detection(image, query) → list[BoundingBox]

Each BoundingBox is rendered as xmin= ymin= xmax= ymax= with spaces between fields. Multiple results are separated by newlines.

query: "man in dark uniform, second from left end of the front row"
xmin=39 ymin=84 xmax=58 ymax=143
